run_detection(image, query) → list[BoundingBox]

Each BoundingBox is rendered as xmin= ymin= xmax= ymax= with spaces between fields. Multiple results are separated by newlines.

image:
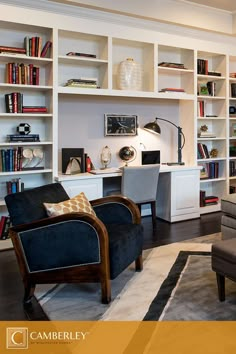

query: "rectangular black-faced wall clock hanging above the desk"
xmin=105 ymin=114 xmax=138 ymax=136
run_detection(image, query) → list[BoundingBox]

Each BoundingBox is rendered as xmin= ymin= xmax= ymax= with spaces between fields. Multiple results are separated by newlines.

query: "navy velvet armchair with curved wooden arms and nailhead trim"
xmin=5 ymin=183 xmax=143 ymax=303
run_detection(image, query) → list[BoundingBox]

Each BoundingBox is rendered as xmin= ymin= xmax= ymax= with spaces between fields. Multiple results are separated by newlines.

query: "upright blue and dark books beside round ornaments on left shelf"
xmin=0 ymin=146 xmax=23 ymax=172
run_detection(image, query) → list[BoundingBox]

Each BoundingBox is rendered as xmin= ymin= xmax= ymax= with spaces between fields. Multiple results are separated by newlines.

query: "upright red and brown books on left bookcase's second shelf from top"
xmin=6 ymin=63 xmax=40 ymax=85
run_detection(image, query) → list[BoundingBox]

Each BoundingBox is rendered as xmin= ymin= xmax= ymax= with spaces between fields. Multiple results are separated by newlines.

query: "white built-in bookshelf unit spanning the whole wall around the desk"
xmin=0 ymin=2 xmax=236 ymax=249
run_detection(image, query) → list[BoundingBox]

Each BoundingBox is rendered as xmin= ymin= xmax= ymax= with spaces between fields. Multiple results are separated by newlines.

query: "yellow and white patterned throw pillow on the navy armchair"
xmin=43 ymin=192 xmax=96 ymax=216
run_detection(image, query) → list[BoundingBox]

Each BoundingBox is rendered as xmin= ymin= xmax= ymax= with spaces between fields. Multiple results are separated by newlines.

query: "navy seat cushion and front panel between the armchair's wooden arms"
xmin=106 ymin=224 xmax=143 ymax=279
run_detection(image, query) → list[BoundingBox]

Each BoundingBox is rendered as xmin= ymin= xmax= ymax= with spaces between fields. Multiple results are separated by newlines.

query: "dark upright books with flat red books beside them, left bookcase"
xmin=5 ymin=92 xmax=47 ymax=113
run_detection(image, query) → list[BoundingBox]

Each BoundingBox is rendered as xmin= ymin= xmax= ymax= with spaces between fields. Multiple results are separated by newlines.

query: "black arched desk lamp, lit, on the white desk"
xmin=143 ymin=117 xmax=185 ymax=166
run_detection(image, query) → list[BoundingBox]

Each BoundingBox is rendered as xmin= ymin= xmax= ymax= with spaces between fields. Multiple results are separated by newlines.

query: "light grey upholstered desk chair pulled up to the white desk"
xmin=121 ymin=164 xmax=160 ymax=228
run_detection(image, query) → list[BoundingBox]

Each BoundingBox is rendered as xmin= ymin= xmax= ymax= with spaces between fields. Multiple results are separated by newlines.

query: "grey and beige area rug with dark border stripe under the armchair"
xmin=36 ymin=234 xmax=236 ymax=321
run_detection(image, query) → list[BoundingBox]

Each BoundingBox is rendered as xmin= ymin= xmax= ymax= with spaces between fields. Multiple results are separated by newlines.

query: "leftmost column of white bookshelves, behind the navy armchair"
xmin=0 ymin=22 xmax=55 ymax=227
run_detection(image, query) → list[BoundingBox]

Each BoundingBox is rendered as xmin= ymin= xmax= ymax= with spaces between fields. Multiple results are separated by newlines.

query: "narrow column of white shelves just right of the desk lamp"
xmin=196 ymin=51 xmax=228 ymax=205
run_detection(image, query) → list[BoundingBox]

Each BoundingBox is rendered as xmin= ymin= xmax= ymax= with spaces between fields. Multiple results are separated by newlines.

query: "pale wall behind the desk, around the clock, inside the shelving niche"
xmin=58 ymin=95 xmax=179 ymax=169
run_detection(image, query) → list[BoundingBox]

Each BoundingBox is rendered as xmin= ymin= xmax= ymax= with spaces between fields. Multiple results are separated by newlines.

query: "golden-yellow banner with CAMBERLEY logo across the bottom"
xmin=0 ymin=321 xmax=236 ymax=354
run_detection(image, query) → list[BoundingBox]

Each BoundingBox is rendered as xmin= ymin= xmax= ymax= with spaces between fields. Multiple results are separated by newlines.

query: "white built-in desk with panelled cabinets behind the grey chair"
xmin=56 ymin=165 xmax=200 ymax=222
